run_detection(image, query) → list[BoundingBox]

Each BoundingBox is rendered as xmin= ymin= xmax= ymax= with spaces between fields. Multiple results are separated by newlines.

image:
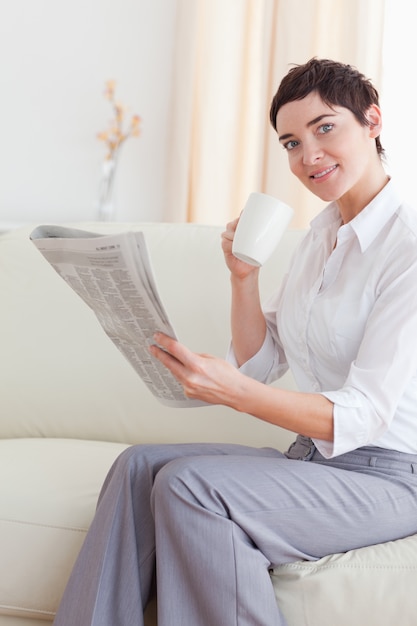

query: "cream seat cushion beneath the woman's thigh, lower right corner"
xmin=272 ymin=535 xmax=417 ymax=626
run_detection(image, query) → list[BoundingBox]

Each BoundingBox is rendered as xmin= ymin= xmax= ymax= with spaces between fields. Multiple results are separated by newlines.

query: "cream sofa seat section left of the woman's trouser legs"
xmin=0 ymin=439 xmax=127 ymax=620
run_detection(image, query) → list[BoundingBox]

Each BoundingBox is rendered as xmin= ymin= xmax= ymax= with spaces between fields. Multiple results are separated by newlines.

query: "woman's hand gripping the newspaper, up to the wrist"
xmin=149 ymin=333 xmax=245 ymax=410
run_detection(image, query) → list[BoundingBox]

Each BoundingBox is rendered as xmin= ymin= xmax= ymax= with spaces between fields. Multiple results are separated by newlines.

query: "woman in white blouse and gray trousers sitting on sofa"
xmin=55 ymin=59 xmax=417 ymax=626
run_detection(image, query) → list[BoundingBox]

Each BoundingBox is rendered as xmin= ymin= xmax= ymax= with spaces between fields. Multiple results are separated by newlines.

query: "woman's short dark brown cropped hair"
xmin=269 ymin=57 xmax=384 ymax=156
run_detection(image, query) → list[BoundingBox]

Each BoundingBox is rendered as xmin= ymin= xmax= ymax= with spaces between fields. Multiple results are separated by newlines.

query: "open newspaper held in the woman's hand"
xmin=30 ymin=226 xmax=206 ymax=407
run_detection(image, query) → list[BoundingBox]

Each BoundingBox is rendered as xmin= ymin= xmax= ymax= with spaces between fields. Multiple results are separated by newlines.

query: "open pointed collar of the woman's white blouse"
xmin=311 ymin=180 xmax=401 ymax=252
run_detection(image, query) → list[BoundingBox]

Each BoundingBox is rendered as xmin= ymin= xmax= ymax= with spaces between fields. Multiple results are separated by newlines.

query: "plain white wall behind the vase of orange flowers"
xmin=0 ymin=0 xmax=176 ymax=223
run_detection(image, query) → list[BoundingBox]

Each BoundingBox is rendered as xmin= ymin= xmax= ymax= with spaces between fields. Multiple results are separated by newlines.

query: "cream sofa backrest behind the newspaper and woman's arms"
xmin=0 ymin=223 xmax=302 ymax=445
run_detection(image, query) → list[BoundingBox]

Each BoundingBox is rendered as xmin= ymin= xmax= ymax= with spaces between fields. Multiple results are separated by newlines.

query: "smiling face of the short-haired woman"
xmin=277 ymin=92 xmax=381 ymax=202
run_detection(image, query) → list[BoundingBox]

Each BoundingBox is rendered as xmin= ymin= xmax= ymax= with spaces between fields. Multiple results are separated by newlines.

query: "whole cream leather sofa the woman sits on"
xmin=0 ymin=223 xmax=417 ymax=626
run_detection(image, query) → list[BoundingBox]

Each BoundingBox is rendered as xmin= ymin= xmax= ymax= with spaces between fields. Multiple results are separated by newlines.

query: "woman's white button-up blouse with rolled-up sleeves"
xmin=231 ymin=182 xmax=417 ymax=458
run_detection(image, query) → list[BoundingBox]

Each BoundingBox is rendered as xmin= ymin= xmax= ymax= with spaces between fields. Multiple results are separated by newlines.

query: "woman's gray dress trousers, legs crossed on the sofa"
xmin=54 ymin=438 xmax=417 ymax=626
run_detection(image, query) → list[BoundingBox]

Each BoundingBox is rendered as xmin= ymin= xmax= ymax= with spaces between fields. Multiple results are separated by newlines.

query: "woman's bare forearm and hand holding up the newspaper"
xmin=150 ymin=333 xmax=333 ymax=441
